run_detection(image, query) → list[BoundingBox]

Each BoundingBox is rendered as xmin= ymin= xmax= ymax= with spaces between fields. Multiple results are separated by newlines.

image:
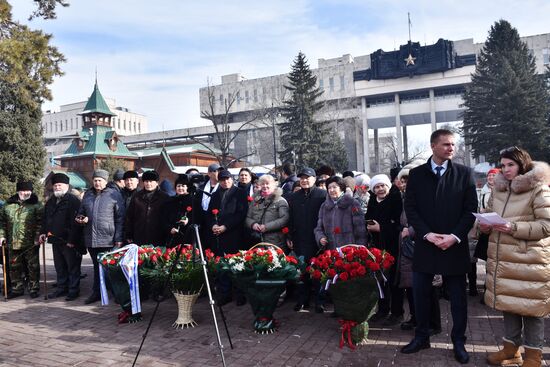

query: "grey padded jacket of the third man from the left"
xmin=77 ymin=187 xmax=126 ymax=248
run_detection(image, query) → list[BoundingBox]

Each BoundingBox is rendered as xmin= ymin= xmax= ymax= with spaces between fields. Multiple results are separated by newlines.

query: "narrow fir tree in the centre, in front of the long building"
xmin=279 ymin=52 xmax=347 ymax=170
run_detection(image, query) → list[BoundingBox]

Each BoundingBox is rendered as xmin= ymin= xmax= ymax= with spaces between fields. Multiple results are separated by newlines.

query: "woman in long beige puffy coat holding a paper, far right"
xmin=480 ymin=147 xmax=550 ymax=367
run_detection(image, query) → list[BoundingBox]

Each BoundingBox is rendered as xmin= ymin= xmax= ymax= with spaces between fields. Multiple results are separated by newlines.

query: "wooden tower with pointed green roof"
xmin=55 ymin=79 xmax=138 ymax=182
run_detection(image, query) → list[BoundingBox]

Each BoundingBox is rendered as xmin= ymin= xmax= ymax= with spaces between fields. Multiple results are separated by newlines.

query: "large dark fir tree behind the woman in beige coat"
xmin=463 ymin=20 xmax=550 ymax=162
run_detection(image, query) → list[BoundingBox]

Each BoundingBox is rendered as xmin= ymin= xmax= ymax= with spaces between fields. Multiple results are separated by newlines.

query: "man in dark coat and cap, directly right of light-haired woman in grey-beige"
xmin=287 ymin=167 xmax=327 ymax=311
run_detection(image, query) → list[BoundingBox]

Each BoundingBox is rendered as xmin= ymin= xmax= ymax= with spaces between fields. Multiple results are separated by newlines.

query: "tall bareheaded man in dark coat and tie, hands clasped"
xmin=401 ymin=129 xmax=477 ymax=363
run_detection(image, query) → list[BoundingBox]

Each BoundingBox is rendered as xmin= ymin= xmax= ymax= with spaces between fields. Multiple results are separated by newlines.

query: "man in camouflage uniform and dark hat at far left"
xmin=0 ymin=182 xmax=43 ymax=298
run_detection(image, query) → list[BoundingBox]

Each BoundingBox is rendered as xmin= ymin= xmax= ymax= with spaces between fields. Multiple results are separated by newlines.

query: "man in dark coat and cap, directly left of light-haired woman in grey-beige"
xmin=206 ymin=170 xmax=248 ymax=305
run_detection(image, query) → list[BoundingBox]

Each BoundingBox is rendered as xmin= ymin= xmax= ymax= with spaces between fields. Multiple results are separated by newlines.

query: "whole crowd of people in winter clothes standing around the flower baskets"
xmin=0 ymin=130 xmax=550 ymax=366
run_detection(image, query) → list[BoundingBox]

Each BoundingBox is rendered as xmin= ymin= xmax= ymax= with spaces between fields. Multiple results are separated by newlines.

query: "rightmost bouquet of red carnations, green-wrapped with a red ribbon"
xmin=306 ymin=245 xmax=395 ymax=349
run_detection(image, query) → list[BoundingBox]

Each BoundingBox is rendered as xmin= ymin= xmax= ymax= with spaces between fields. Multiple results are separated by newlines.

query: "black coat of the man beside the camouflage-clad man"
xmin=40 ymin=192 xmax=80 ymax=244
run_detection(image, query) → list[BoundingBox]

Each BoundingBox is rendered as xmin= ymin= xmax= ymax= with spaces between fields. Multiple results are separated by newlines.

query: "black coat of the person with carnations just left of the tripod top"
xmin=162 ymin=194 xmax=193 ymax=247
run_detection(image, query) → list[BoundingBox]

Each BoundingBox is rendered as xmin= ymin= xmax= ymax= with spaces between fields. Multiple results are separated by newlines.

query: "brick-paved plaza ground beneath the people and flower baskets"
xmin=0 ymin=249 xmax=550 ymax=367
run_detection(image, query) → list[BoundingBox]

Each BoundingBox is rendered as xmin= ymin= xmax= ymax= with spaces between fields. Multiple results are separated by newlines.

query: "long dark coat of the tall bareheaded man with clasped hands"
xmin=405 ymin=158 xmax=477 ymax=275
